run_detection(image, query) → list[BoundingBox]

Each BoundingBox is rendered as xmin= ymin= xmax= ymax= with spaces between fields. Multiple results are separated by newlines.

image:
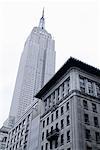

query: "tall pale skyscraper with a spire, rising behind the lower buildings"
xmin=9 ymin=10 xmax=55 ymax=126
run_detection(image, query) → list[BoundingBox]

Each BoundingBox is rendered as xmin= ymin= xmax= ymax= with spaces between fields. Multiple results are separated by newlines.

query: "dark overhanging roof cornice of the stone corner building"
xmin=35 ymin=57 xmax=100 ymax=98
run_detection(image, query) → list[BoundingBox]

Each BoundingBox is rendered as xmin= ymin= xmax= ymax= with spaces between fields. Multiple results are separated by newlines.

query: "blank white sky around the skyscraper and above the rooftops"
xmin=0 ymin=0 xmax=100 ymax=126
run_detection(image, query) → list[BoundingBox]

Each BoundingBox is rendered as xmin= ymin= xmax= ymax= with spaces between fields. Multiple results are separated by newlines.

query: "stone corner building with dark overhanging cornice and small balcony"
xmin=36 ymin=58 xmax=100 ymax=150
